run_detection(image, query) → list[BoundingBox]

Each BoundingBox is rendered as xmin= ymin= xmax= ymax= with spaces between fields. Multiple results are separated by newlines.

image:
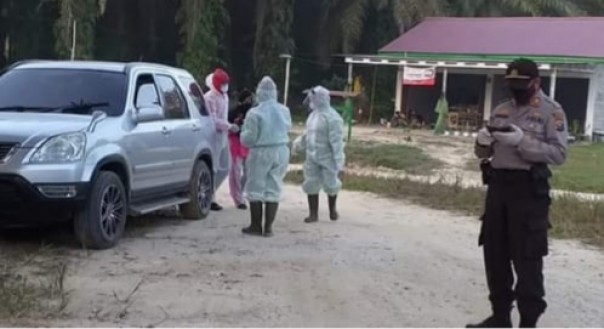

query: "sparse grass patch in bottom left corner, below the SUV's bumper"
xmin=0 ymin=247 xmax=69 ymax=321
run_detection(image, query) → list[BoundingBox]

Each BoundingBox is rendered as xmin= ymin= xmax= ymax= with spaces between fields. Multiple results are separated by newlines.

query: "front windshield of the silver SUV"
xmin=0 ymin=69 xmax=127 ymax=116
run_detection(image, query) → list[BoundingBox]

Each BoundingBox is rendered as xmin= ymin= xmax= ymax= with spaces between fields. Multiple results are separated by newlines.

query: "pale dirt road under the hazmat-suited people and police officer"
xmin=8 ymin=187 xmax=604 ymax=327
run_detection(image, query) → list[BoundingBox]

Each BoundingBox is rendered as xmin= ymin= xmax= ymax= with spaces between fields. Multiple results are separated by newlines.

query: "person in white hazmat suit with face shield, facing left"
xmin=293 ymin=86 xmax=346 ymax=223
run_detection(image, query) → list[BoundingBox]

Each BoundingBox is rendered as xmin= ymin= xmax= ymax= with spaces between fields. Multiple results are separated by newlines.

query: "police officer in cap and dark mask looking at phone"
xmin=467 ymin=59 xmax=568 ymax=328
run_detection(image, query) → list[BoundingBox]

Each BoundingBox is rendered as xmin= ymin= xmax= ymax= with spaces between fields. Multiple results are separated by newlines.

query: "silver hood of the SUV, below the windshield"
xmin=0 ymin=113 xmax=92 ymax=147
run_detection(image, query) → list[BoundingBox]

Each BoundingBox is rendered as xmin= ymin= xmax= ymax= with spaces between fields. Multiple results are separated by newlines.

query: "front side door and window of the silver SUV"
xmin=124 ymin=73 xmax=173 ymax=193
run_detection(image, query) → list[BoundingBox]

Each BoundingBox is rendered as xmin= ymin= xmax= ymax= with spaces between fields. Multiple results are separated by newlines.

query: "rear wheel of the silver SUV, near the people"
xmin=180 ymin=161 xmax=214 ymax=220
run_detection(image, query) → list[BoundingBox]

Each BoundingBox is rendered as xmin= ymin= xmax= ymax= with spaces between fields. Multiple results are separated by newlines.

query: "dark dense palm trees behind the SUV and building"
xmin=0 ymin=0 xmax=604 ymax=118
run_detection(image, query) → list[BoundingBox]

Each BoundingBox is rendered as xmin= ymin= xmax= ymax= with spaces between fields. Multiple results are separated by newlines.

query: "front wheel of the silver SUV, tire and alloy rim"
xmin=74 ymin=171 xmax=128 ymax=250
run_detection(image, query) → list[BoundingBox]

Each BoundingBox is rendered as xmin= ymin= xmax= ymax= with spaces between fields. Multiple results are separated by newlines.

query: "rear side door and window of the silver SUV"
xmin=155 ymin=74 xmax=200 ymax=183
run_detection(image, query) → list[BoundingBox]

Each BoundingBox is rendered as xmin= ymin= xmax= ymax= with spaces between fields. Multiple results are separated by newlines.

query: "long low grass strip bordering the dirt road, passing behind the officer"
xmin=286 ymin=172 xmax=604 ymax=247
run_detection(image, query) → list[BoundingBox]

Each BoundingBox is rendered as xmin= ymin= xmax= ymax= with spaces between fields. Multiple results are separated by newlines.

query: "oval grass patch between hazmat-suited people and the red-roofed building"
xmin=291 ymin=141 xmax=441 ymax=175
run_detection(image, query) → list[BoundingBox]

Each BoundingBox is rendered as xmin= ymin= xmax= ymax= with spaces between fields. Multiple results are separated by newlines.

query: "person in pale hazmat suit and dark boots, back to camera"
xmin=241 ymin=77 xmax=292 ymax=237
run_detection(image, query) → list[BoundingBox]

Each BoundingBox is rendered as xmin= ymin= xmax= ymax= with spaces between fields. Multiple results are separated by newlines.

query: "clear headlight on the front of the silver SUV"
xmin=30 ymin=133 xmax=86 ymax=163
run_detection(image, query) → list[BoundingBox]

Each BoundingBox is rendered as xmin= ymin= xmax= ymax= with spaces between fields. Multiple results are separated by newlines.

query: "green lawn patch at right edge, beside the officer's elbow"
xmin=552 ymin=143 xmax=604 ymax=193
